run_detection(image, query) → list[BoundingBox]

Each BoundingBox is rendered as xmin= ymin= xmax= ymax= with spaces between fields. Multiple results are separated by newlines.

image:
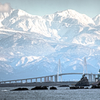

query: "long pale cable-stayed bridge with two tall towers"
xmin=0 ymin=58 xmax=98 ymax=84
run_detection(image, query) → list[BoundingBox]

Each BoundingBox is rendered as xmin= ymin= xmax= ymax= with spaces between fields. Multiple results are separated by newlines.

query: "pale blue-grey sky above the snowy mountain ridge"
xmin=0 ymin=0 xmax=100 ymax=18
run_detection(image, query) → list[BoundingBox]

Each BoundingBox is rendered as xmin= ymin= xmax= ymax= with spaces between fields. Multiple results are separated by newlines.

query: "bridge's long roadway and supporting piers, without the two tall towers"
xmin=0 ymin=73 xmax=98 ymax=84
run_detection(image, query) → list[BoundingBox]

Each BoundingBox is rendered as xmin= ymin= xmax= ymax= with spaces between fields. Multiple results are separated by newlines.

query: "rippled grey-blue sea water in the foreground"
xmin=0 ymin=87 xmax=100 ymax=100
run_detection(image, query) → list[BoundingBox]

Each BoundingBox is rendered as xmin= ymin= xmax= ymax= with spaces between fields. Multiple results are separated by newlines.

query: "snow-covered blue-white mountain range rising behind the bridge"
xmin=0 ymin=9 xmax=100 ymax=80
